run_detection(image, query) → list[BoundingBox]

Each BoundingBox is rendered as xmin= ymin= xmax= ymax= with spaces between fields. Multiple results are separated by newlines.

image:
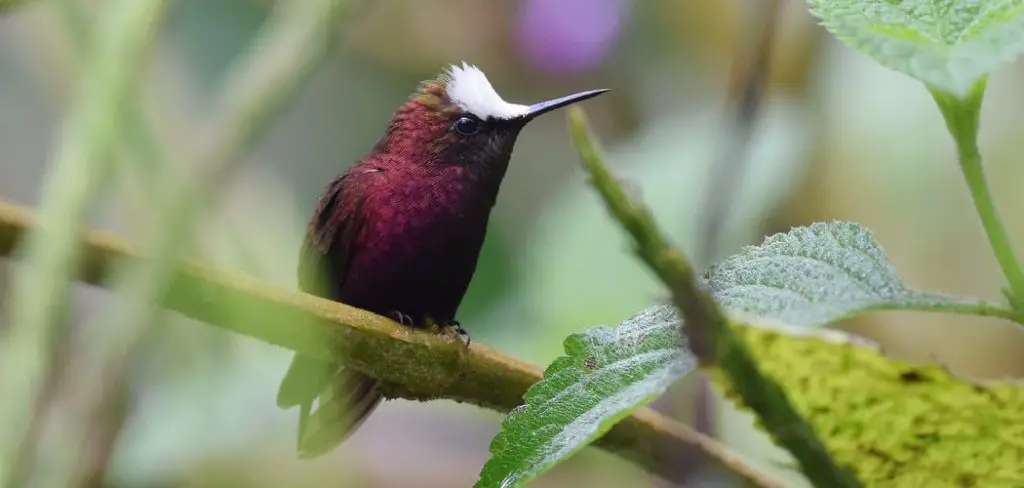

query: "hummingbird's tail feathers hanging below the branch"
xmin=278 ymin=355 xmax=382 ymax=458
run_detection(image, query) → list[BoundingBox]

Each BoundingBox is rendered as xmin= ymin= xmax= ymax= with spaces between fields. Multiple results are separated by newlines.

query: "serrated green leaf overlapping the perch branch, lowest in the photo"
xmin=474 ymin=305 xmax=696 ymax=488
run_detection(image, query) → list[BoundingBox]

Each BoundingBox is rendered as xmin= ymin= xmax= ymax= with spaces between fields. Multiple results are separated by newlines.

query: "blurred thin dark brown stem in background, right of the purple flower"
xmin=697 ymin=0 xmax=780 ymax=264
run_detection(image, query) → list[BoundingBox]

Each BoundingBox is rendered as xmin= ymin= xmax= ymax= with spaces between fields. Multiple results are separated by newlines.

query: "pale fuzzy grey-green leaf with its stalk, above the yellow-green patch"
xmin=705 ymin=222 xmax=1013 ymax=327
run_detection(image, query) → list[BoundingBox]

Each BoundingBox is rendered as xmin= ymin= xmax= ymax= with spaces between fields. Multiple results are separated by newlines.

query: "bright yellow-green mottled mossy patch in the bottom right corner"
xmin=712 ymin=325 xmax=1024 ymax=488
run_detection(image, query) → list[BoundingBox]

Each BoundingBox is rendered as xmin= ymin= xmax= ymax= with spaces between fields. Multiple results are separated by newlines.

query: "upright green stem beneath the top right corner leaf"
xmin=929 ymin=78 xmax=1024 ymax=310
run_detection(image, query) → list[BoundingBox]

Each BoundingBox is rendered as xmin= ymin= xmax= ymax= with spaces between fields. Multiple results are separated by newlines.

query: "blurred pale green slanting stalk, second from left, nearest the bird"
xmin=34 ymin=0 xmax=360 ymax=486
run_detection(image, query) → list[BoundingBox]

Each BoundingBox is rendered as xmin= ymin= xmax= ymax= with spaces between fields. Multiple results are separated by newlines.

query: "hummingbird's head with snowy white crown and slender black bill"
xmin=375 ymin=62 xmax=607 ymax=168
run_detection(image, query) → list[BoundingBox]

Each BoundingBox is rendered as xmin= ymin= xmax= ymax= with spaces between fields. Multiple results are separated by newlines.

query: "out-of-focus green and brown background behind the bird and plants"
xmin=0 ymin=0 xmax=1024 ymax=488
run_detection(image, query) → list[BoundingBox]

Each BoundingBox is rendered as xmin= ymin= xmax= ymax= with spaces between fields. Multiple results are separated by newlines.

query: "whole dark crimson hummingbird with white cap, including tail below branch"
xmin=278 ymin=61 xmax=608 ymax=458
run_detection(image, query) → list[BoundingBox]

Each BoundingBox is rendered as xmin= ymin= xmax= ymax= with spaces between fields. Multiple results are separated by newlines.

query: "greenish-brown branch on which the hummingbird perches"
xmin=0 ymin=201 xmax=776 ymax=486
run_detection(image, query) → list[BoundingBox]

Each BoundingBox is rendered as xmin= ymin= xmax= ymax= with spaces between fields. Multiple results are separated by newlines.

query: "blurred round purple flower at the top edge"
xmin=517 ymin=0 xmax=630 ymax=74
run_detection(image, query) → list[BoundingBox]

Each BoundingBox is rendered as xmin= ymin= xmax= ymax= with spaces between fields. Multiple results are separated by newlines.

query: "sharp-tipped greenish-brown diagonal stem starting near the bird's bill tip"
xmin=568 ymin=107 xmax=861 ymax=488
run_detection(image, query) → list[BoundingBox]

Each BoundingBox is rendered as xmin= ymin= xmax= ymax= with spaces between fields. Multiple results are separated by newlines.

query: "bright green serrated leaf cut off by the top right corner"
xmin=807 ymin=0 xmax=1024 ymax=95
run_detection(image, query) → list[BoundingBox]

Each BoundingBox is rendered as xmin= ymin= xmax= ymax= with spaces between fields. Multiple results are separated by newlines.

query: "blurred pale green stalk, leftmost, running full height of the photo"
xmin=0 ymin=0 xmax=165 ymax=486
